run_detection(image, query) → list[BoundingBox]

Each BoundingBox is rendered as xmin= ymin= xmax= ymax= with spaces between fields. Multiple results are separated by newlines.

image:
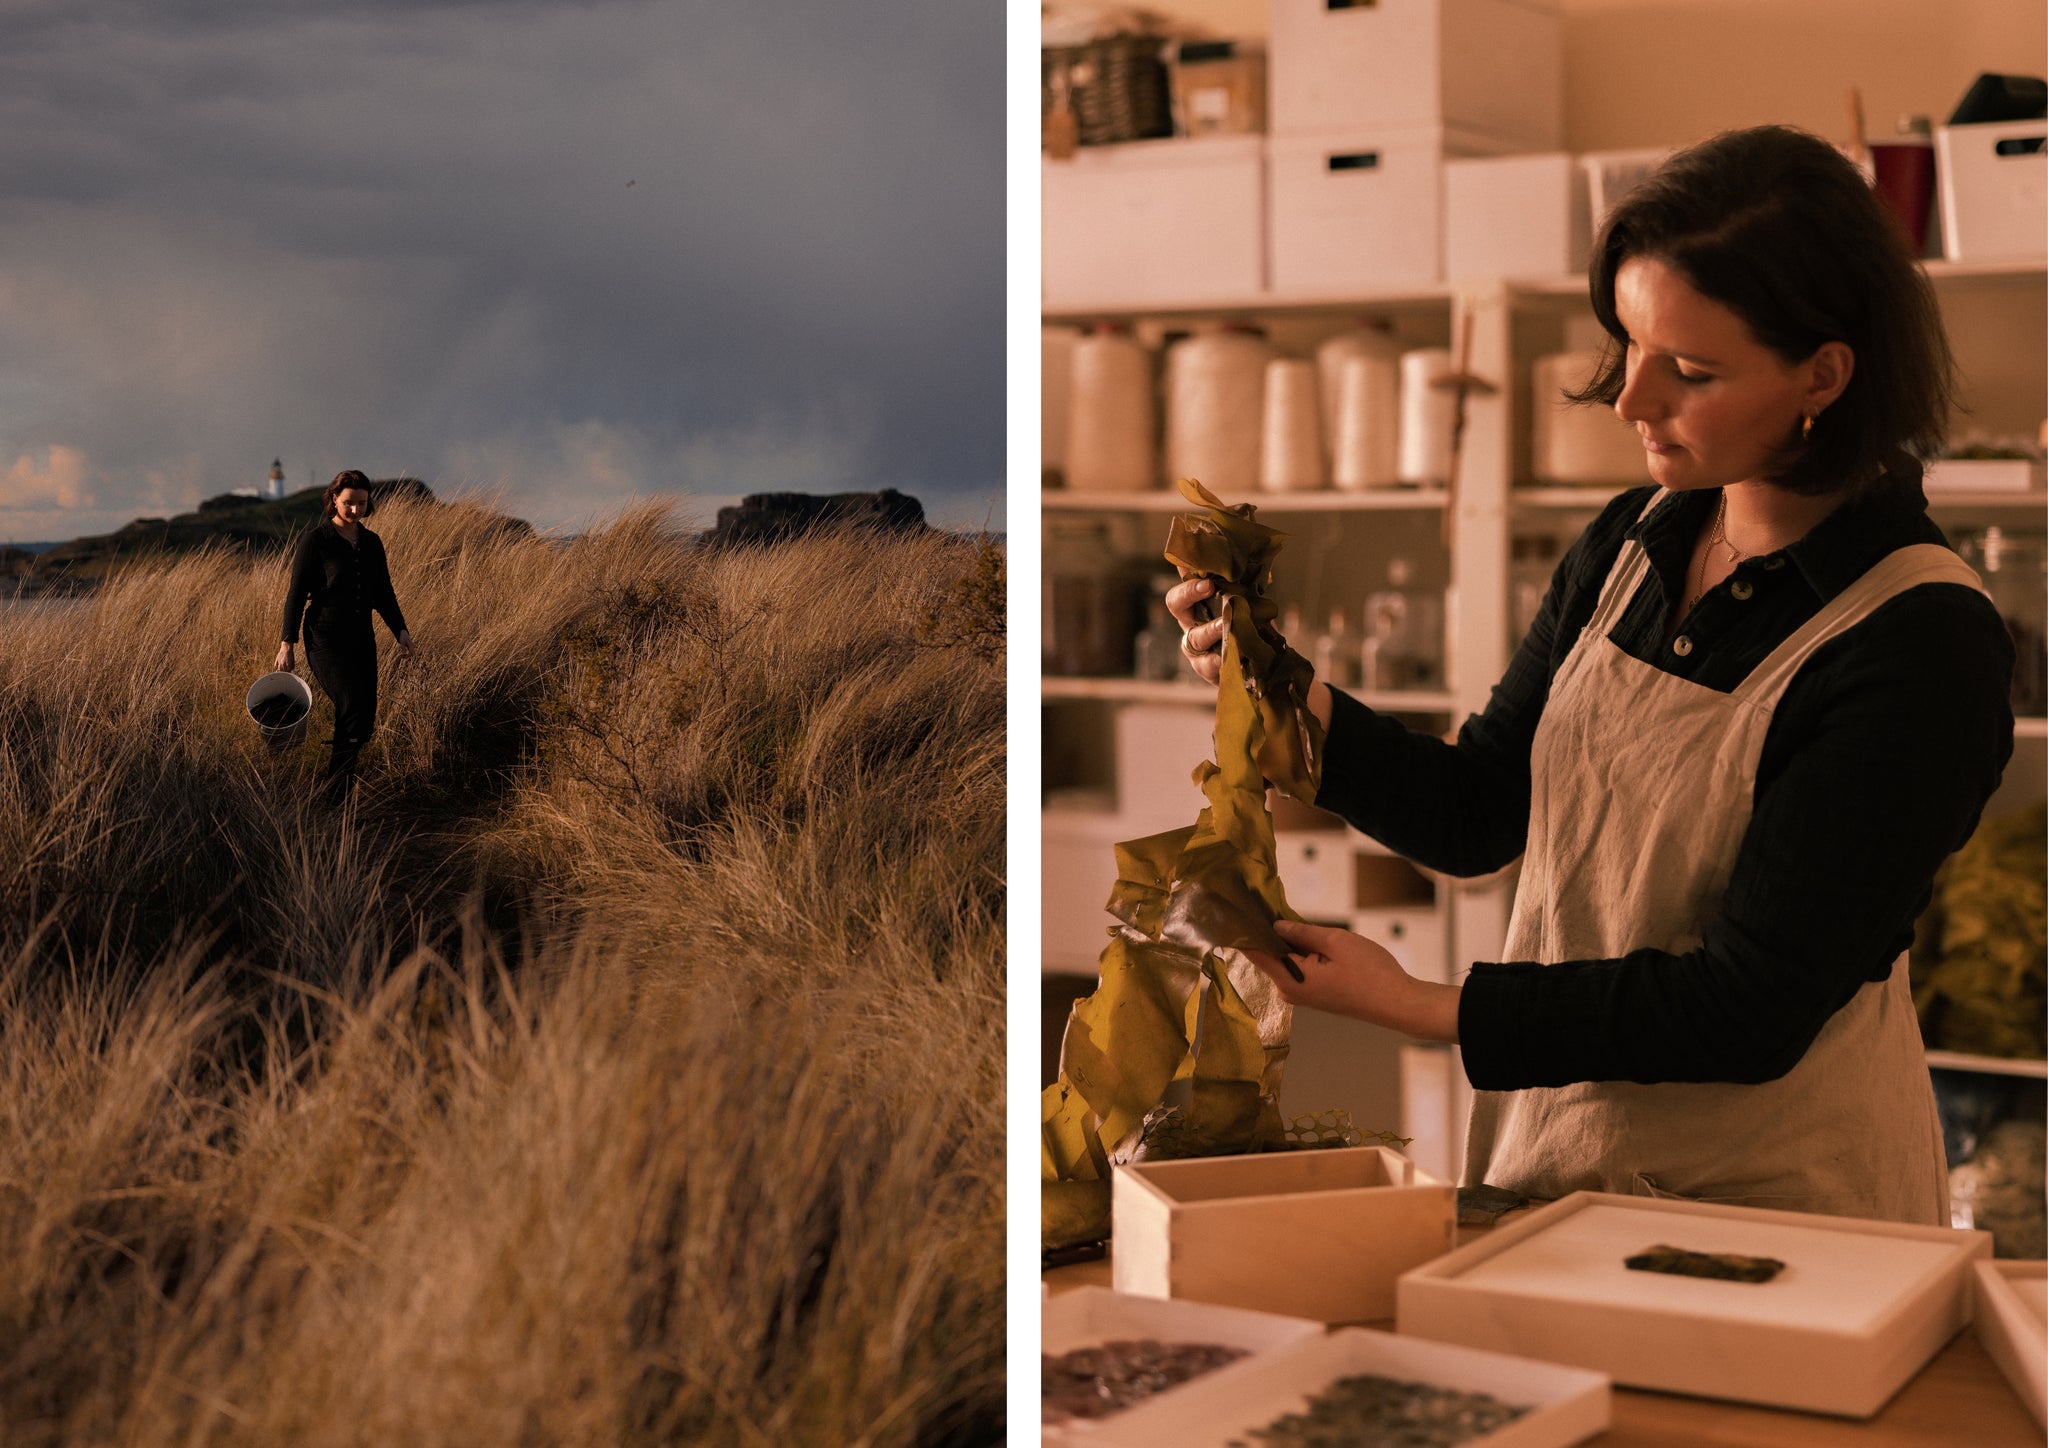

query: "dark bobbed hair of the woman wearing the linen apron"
xmin=1569 ymin=125 xmax=1956 ymax=494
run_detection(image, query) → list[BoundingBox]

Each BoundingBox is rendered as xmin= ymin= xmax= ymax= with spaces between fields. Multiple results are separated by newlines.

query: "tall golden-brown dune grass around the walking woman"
xmin=0 ymin=504 xmax=1004 ymax=1448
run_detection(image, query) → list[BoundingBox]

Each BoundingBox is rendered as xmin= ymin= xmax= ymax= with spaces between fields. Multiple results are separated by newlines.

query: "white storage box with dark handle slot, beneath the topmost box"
xmin=1266 ymin=127 xmax=1497 ymax=295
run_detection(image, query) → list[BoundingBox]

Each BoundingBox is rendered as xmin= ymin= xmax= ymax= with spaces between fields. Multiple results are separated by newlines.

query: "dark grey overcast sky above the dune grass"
xmin=0 ymin=0 xmax=1004 ymax=541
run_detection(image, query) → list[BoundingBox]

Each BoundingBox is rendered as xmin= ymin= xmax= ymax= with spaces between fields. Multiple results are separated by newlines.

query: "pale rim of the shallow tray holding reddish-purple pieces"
xmin=1038 ymin=1286 xmax=1323 ymax=1448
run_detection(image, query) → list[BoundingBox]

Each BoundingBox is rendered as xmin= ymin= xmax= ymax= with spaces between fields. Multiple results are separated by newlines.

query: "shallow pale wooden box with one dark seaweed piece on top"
xmin=1397 ymin=1192 xmax=1991 ymax=1417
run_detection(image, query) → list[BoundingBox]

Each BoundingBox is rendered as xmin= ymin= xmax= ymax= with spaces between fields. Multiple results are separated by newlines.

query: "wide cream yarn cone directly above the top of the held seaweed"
xmin=1165 ymin=328 xmax=1276 ymax=494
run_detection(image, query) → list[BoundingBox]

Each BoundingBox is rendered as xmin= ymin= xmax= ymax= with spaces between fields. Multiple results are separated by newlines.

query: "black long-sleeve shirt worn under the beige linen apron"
xmin=1317 ymin=469 xmax=2013 ymax=1090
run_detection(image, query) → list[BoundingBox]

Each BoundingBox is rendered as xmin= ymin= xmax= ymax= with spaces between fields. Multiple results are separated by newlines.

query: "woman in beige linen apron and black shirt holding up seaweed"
xmin=1167 ymin=127 xmax=2013 ymax=1225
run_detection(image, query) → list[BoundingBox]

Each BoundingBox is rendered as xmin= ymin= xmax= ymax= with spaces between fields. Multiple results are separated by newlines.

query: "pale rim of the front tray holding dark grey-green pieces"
xmin=1087 ymin=1327 xmax=1614 ymax=1448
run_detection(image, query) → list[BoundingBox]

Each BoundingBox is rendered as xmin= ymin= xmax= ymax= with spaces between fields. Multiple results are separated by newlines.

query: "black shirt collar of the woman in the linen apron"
xmin=1628 ymin=459 xmax=1942 ymax=602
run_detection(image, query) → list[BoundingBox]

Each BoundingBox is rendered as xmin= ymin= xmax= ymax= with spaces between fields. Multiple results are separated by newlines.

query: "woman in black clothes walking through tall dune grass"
xmin=274 ymin=467 xmax=412 ymax=793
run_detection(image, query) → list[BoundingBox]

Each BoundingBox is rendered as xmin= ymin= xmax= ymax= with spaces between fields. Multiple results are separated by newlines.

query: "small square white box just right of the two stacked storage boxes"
xmin=1444 ymin=152 xmax=1591 ymax=283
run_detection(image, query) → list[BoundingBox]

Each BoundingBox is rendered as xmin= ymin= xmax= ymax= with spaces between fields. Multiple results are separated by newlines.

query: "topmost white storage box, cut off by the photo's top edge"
xmin=1266 ymin=0 xmax=1565 ymax=152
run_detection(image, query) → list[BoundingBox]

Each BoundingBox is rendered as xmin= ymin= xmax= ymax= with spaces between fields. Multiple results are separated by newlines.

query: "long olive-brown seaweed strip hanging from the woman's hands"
xmin=1038 ymin=479 xmax=1323 ymax=1247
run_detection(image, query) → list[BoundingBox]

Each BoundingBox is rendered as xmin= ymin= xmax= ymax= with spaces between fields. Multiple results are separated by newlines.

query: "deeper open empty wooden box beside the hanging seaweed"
xmin=1110 ymin=1147 xmax=1458 ymax=1323
